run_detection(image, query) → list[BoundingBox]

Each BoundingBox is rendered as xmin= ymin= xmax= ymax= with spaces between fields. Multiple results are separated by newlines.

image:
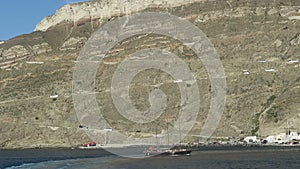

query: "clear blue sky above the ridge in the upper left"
xmin=0 ymin=0 xmax=87 ymax=40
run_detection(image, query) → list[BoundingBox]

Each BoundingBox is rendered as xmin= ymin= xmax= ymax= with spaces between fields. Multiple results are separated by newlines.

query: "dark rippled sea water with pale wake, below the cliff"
xmin=0 ymin=147 xmax=300 ymax=169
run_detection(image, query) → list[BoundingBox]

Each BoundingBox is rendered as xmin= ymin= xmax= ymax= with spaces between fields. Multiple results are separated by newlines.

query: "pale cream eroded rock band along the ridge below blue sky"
xmin=35 ymin=0 xmax=203 ymax=31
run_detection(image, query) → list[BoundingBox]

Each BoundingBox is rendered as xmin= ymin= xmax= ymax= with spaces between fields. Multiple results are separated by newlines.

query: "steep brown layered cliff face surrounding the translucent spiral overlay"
xmin=0 ymin=0 xmax=300 ymax=147
